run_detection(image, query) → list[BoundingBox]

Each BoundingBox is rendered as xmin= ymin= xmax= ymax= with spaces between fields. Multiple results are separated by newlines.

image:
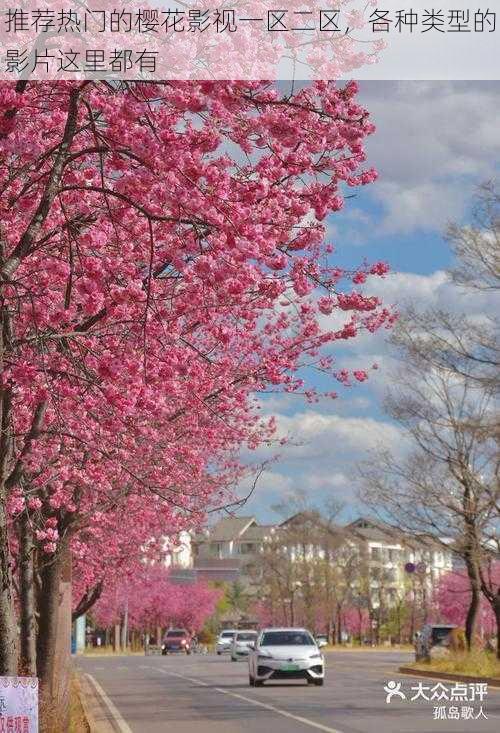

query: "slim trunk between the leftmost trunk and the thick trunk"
xmin=18 ymin=512 xmax=36 ymax=676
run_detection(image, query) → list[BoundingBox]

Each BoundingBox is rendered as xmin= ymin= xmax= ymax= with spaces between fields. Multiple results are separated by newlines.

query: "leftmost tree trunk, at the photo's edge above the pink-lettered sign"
xmin=0 ymin=492 xmax=17 ymax=677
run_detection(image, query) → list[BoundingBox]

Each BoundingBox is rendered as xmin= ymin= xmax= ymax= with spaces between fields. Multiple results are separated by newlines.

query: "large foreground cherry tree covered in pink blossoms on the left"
xmin=0 ymin=81 xmax=394 ymax=685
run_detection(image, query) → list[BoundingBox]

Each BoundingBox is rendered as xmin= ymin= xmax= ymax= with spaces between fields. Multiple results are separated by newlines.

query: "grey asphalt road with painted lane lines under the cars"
xmin=77 ymin=651 xmax=500 ymax=733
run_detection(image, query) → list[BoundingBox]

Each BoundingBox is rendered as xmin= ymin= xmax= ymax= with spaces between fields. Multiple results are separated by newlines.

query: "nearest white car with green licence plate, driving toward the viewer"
xmin=248 ymin=629 xmax=325 ymax=687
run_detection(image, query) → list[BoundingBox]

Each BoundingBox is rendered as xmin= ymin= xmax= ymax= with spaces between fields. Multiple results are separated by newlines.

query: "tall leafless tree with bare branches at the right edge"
xmin=362 ymin=184 xmax=500 ymax=656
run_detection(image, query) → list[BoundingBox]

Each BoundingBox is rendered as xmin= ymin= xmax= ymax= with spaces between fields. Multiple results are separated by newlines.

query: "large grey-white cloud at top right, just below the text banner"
xmin=360 ymin=81 xmax=500 ymax=235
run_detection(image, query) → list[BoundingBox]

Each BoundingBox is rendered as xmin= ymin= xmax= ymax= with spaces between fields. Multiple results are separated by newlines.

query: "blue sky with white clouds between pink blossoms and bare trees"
xmin=232 ymin=82 xmax=500 ymax=522
